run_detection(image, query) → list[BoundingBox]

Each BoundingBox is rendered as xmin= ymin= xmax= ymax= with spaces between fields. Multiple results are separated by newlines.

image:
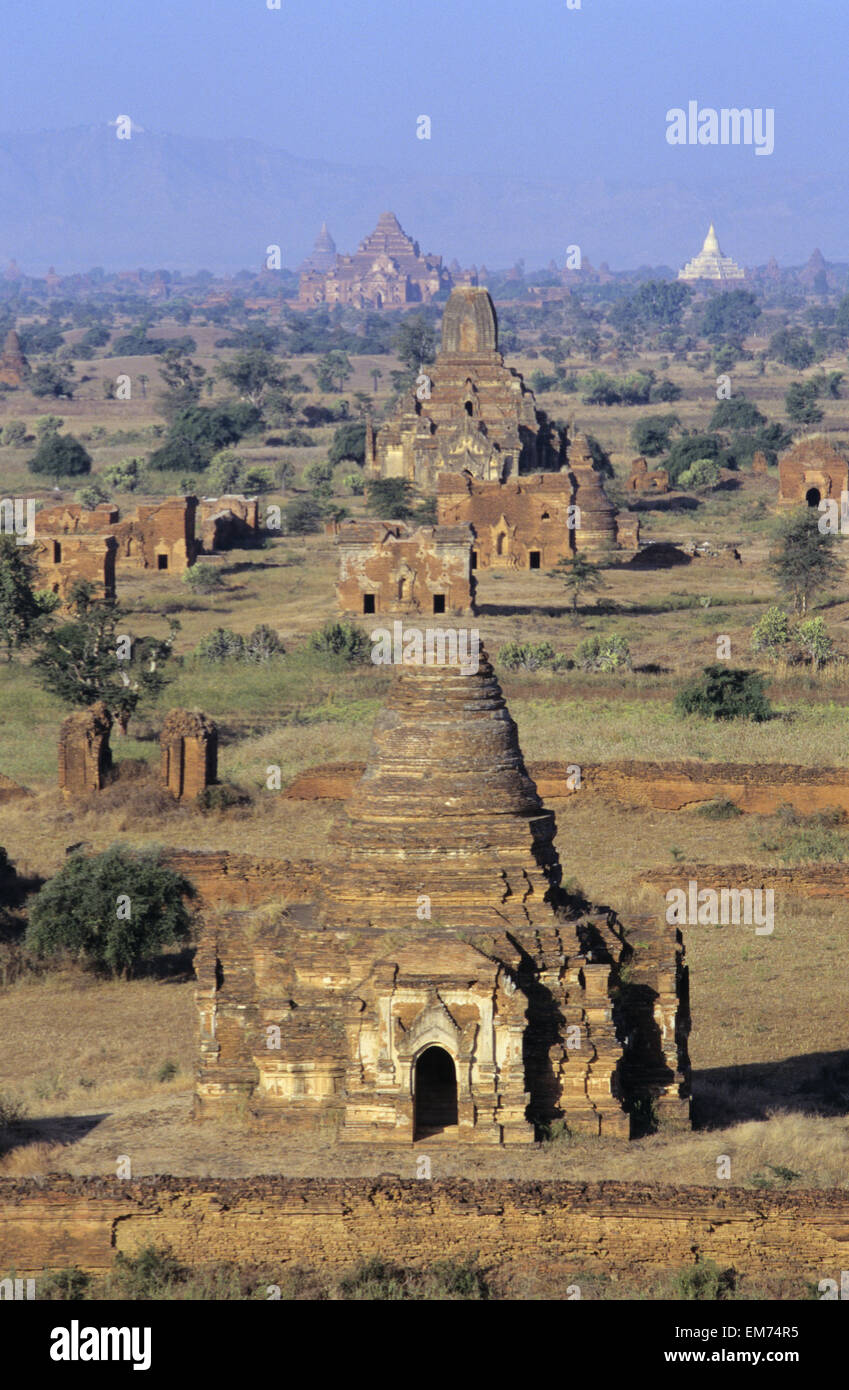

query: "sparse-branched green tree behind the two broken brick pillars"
xmin=32 ymin=581 xmax=179 ymax=734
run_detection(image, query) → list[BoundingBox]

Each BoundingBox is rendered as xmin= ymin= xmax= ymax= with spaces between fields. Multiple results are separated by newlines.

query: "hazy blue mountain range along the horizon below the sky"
xmin=0 ymin=125 xmax=849 ymax=275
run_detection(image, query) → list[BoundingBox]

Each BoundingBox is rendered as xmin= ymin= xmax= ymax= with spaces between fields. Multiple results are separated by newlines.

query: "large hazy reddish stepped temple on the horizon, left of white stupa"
xmin=297 ymin=213 xmax=477 ymax=309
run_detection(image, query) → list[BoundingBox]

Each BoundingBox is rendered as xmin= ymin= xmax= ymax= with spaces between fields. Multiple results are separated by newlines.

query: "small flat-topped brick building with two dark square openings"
xmin=336 ymin=521 xmax=474 ymax=617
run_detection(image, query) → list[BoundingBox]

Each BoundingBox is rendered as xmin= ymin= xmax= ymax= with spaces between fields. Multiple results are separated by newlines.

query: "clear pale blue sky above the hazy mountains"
xmin=0 ymin=0 xmax=849 ymax=268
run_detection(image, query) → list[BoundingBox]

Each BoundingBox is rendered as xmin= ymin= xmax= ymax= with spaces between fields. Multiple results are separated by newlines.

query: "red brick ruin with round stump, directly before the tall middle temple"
xmin=436 ymin=434 xmax=639 ymax=570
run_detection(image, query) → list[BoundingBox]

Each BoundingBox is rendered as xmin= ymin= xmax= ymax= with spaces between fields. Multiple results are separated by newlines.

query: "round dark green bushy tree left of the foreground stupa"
xmin=25 ymin=845 xmax=192 ymax=980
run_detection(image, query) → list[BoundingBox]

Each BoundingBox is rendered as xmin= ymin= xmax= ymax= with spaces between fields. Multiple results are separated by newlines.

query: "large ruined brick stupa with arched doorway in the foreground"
xmin=197 ymin=656 xmax=688 ymax=1144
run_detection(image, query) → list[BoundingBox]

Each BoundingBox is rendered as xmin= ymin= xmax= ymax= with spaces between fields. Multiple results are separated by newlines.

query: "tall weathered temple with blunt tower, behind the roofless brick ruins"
xmin=365 ymin=285 xmax=563 ymax=489
